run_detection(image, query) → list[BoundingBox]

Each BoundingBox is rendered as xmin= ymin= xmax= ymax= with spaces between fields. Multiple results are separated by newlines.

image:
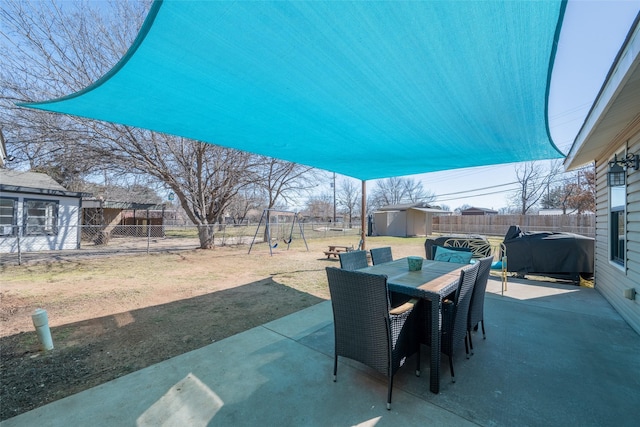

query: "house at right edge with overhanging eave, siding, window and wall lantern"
xmin=565 ymin=15 xmax=640 ymax=333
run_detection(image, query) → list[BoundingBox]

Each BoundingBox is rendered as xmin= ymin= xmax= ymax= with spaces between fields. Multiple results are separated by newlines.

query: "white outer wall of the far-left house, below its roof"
xmin=0 ymin=191 xmax=81 ymax=253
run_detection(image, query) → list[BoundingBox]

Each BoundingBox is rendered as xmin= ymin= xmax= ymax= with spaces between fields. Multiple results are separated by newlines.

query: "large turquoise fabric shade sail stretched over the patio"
xmin=22 ymin=0 xmax=566 ymax=180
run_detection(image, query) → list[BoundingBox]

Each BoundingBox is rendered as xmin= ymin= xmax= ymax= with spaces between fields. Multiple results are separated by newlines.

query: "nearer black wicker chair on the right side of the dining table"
xmin=441 ymin=263 xmax=480 ymax=382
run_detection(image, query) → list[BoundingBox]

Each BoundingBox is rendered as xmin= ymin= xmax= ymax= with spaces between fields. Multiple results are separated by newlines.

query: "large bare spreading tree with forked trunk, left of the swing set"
xmin=87 ymin=121 xmax=261 ymax=249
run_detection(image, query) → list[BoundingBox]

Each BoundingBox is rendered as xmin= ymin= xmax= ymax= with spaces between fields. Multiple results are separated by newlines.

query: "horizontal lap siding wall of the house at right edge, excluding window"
xmin=595 ymin=130 xmax=640 ymax=334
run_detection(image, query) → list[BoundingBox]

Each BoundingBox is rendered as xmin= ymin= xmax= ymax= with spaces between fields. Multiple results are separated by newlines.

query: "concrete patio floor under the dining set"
xmin=1 ymin=277 xmax=640 ymax=427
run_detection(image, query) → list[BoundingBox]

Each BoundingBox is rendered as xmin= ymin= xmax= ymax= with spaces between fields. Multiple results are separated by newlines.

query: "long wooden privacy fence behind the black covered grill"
xmin=432 ymin=214 xmax=596 ymax=241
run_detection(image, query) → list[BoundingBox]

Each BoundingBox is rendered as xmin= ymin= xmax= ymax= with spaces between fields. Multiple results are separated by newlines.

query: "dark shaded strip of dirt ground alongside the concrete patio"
xmin=0 ymin=279 xmax=321 ymax=419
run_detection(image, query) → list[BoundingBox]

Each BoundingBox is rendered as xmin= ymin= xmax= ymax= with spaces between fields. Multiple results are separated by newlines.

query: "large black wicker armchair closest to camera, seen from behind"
xmin=326 ymin=267 xmax=420 ymax=409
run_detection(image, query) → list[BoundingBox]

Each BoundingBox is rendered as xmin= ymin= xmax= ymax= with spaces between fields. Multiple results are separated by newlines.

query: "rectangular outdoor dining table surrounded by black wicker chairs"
xmin=358 ymin=258 xmax=468 ymax=393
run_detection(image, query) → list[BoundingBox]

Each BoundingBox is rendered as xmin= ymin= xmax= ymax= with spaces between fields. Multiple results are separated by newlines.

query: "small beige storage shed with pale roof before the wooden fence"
xmin=373 ymin=203 xmax=451 ymax=237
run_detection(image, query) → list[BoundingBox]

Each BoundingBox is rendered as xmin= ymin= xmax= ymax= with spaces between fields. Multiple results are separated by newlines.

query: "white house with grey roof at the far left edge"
xmin=0 ymin=169 xmax=83 ymax=253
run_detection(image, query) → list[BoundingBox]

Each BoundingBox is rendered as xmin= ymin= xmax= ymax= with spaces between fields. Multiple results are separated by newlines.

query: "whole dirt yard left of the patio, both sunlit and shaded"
xmin=0 ymin=239 xmax=348 ymax=420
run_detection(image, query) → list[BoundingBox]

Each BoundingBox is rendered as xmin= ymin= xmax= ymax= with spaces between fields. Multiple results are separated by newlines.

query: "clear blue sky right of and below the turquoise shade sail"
xmin=360 ymin=0 xmax=640 ymax=210
